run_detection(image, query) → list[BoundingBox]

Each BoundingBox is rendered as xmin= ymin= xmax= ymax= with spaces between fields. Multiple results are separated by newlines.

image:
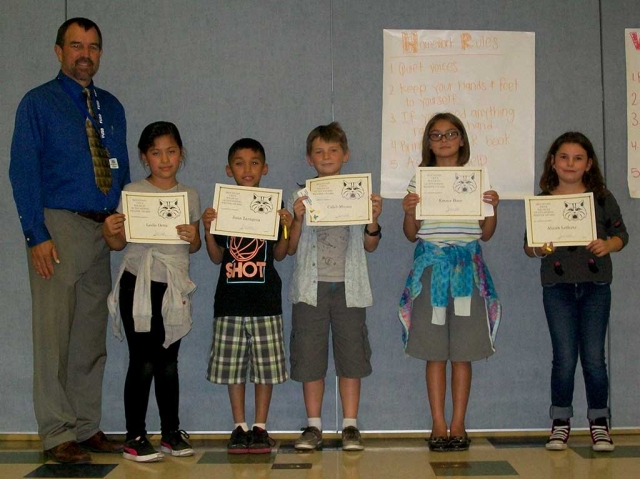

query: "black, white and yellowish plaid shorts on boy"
xmin=207 ymin=315 xmax=288 ymax=384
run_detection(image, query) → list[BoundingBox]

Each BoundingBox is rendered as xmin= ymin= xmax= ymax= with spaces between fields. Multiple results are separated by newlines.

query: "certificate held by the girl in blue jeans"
xmin=524 ymin=193 xmax=598 ymax=248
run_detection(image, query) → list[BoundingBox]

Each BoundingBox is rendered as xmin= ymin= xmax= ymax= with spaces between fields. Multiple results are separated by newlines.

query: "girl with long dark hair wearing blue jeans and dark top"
xmin=524 ymin=132 xmax=629 ymax=451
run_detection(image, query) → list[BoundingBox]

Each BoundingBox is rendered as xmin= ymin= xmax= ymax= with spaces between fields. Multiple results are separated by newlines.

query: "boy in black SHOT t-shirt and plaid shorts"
xmin=202 ymin=138 xmax=292 ymax=454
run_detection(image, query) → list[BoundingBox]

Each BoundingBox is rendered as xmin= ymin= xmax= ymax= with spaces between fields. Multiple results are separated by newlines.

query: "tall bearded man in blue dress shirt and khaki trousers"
xmin=9 ymin=18 xmax=130 ymax=463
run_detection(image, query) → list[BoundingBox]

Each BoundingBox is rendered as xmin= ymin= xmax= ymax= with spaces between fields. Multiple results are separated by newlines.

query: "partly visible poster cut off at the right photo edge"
xmin=624 ymin=29 xmax=640 ymax=198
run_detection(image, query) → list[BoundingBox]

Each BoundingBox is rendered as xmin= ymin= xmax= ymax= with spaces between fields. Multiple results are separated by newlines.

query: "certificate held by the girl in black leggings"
xmin=122 ymin=191 xmax=189 ymax=244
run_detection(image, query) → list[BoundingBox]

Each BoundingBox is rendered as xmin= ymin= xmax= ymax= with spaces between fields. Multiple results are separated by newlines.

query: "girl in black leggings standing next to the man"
xmin=103 ymin=121 xmax=200 ymax=462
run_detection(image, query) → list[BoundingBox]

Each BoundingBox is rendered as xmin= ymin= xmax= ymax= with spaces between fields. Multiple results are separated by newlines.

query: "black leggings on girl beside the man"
xmin=120 ymin=271 xmax=180 ymax=440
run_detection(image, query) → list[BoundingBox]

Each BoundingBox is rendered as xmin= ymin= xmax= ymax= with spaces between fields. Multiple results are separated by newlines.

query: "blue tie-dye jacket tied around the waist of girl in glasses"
xmin=398 ymin=238 xmax=502 ymax=348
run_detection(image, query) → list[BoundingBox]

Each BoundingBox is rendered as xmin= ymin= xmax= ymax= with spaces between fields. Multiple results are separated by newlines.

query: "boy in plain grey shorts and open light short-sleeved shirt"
xmin=289 ymin=122 xmax=382 ymax=451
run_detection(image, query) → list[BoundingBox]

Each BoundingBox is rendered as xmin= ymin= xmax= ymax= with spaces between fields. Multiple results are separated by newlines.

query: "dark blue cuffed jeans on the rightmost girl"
xmin=542 ymin=282 xmax=611 ymax=420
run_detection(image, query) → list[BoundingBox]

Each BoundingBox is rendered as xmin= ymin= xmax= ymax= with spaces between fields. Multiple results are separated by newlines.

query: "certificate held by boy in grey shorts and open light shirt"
xmin=298 ymin=173 xmax=373 ymax=226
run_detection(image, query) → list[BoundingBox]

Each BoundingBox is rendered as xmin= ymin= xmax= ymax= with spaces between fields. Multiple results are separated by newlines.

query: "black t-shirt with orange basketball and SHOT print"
xmin=213 ymin=235 xmax=282 ymax=317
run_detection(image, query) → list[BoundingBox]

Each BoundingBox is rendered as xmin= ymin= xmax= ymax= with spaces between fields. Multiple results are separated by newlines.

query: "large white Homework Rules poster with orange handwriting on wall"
xmin=381 ymin=30 xmax=535 ymax=199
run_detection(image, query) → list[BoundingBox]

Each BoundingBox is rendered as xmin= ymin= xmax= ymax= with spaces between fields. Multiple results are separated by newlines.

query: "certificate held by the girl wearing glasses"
xmin=416 ymin=166 xmax=484 ymax=220
